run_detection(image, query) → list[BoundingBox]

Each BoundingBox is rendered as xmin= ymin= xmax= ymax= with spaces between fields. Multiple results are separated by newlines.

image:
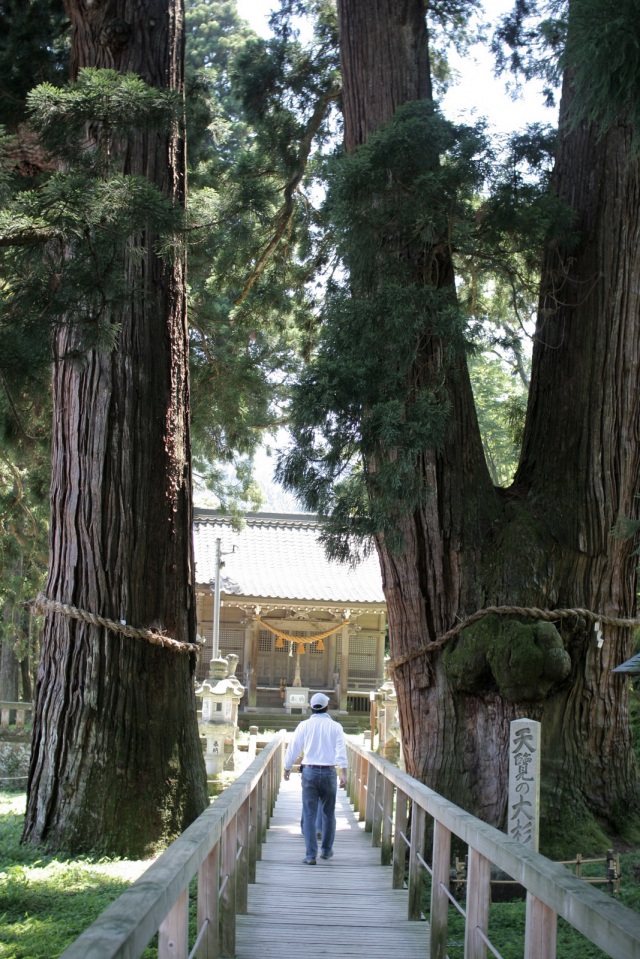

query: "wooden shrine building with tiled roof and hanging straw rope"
xmin=193 ymin=509 xmax=387 ymax=713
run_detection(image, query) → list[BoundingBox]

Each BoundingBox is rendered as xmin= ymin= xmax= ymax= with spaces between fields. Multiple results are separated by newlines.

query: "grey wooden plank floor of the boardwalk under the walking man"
xmin=236 ymin=774 xmax=429 ymax=959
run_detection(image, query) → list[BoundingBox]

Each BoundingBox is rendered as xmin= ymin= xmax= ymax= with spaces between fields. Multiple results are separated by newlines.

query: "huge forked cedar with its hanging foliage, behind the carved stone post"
xmin=281 ymin=0 xmax=640 ymax=849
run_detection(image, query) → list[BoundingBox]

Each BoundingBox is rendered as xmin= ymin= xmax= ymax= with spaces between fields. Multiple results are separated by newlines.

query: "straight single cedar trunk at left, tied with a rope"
xmin=24 ymin=0 xmax=207 ymax=856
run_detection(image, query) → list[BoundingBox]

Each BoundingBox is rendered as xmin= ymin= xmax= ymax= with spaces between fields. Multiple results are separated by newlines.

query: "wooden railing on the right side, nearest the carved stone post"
xmin=347 ymin=741 xmax=640 ymax=959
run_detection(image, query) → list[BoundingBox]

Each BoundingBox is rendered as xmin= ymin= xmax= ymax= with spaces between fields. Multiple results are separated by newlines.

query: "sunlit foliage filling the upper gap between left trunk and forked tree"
xmin=182 ymin=2 xmax=337 ymax=506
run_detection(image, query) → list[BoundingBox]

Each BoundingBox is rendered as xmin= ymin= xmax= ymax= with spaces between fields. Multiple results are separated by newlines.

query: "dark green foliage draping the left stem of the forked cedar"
xmin=278 ymin=102 xmax=488 ymax=556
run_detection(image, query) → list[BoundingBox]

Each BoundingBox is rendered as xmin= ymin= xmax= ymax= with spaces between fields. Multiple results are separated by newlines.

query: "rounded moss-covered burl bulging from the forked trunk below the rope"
xmin=443 ymin=616 xmax=571 ymax=702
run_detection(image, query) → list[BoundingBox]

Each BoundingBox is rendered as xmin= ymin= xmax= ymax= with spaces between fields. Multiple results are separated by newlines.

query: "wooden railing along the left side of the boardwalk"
xmin=60 ymin=732 xmax=285 ymax=959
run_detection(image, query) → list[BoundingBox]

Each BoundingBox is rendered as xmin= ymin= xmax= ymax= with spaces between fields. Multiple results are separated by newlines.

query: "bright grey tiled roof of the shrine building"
xmin=193 ymin=509 xmax=384 ymax=605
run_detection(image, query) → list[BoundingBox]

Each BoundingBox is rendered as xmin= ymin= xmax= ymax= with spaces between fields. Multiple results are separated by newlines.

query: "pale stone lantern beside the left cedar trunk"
xmin=196 ymin=653 xmax=244 ymax=776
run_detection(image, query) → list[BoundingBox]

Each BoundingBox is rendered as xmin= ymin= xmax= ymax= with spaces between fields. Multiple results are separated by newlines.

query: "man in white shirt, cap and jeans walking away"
xmin=284 ymin=693 xmax=347 ymax=866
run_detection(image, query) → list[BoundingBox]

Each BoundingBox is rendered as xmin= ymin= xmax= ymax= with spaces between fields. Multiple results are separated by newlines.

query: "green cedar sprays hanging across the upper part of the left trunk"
xmin=0 ymin=70 xmax=182 ymax=364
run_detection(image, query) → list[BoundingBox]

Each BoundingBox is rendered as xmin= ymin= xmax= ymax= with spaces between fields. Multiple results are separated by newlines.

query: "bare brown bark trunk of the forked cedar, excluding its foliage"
xmin=338 ymin=0 xmax=640 ymax=852
